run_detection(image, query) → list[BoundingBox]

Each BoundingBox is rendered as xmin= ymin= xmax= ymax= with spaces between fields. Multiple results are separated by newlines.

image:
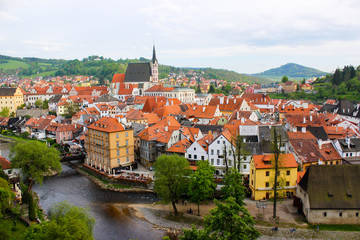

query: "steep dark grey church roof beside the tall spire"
xmin=124 ymin=63 xmax=151 ymax=82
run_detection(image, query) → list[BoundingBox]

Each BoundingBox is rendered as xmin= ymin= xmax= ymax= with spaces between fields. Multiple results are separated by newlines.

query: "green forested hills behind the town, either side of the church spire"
xmin=0 ymin=55 xmax=266 ymax=83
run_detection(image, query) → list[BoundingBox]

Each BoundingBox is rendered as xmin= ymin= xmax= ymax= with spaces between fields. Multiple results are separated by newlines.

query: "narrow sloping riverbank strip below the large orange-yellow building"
xmin=70 ymin=163 xmax=154 ymax=193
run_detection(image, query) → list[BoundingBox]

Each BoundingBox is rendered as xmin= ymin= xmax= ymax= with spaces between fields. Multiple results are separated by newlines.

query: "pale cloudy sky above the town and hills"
xmin=0 ymin=0 xmax=360 ymax=73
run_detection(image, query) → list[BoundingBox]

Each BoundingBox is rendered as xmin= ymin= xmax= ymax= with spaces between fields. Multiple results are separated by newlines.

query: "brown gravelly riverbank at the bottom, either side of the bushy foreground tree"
xmin=129 ymin=202 xmax=360 ymax=240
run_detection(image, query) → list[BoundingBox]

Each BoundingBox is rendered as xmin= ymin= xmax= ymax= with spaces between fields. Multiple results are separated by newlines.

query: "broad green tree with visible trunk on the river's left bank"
xmin=10 ymin=141 xmax=61 ymax=192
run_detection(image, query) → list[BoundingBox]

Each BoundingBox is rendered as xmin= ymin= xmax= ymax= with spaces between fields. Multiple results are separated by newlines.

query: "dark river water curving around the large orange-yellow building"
xmin=0 ymin=141 xmax=164 ymax=240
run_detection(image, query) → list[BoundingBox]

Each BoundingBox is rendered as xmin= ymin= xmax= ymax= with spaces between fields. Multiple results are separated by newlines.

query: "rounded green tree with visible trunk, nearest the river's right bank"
xmin=154 ymin=154 xmax=190 ymax=215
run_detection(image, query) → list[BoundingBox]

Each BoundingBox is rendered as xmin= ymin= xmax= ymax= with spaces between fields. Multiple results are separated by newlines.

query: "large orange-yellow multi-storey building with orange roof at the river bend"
xmin=85 ymin=117 xmax=135 ymax=173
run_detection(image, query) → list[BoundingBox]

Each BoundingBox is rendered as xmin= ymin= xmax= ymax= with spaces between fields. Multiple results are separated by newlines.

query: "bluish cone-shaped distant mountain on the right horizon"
xmin=252 ymin=63 xmax=328 ymax=80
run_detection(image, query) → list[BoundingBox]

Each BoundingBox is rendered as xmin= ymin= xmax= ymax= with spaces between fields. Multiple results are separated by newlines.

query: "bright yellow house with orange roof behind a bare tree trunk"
xmin=249 ymin=153 xmax=298 ymax=200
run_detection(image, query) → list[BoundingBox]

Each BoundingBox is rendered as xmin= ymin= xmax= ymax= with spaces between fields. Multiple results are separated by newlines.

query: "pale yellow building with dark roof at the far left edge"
xmin=0 ymin=88 xmax=24 ymax=114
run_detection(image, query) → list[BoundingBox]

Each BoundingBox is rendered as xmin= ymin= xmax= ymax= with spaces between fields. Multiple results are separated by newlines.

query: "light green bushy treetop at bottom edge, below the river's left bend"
xmin=24 ymin=202 xmax=95 ymax=240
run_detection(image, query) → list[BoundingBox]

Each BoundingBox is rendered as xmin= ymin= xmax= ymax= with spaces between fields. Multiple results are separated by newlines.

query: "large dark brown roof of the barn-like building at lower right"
xmin=299 ymin=165 xmax=360 ymax=209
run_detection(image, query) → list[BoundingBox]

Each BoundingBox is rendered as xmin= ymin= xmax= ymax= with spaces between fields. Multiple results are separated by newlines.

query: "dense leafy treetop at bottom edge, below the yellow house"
xmin=180 ymin=197 xmax=260 ymax=240
